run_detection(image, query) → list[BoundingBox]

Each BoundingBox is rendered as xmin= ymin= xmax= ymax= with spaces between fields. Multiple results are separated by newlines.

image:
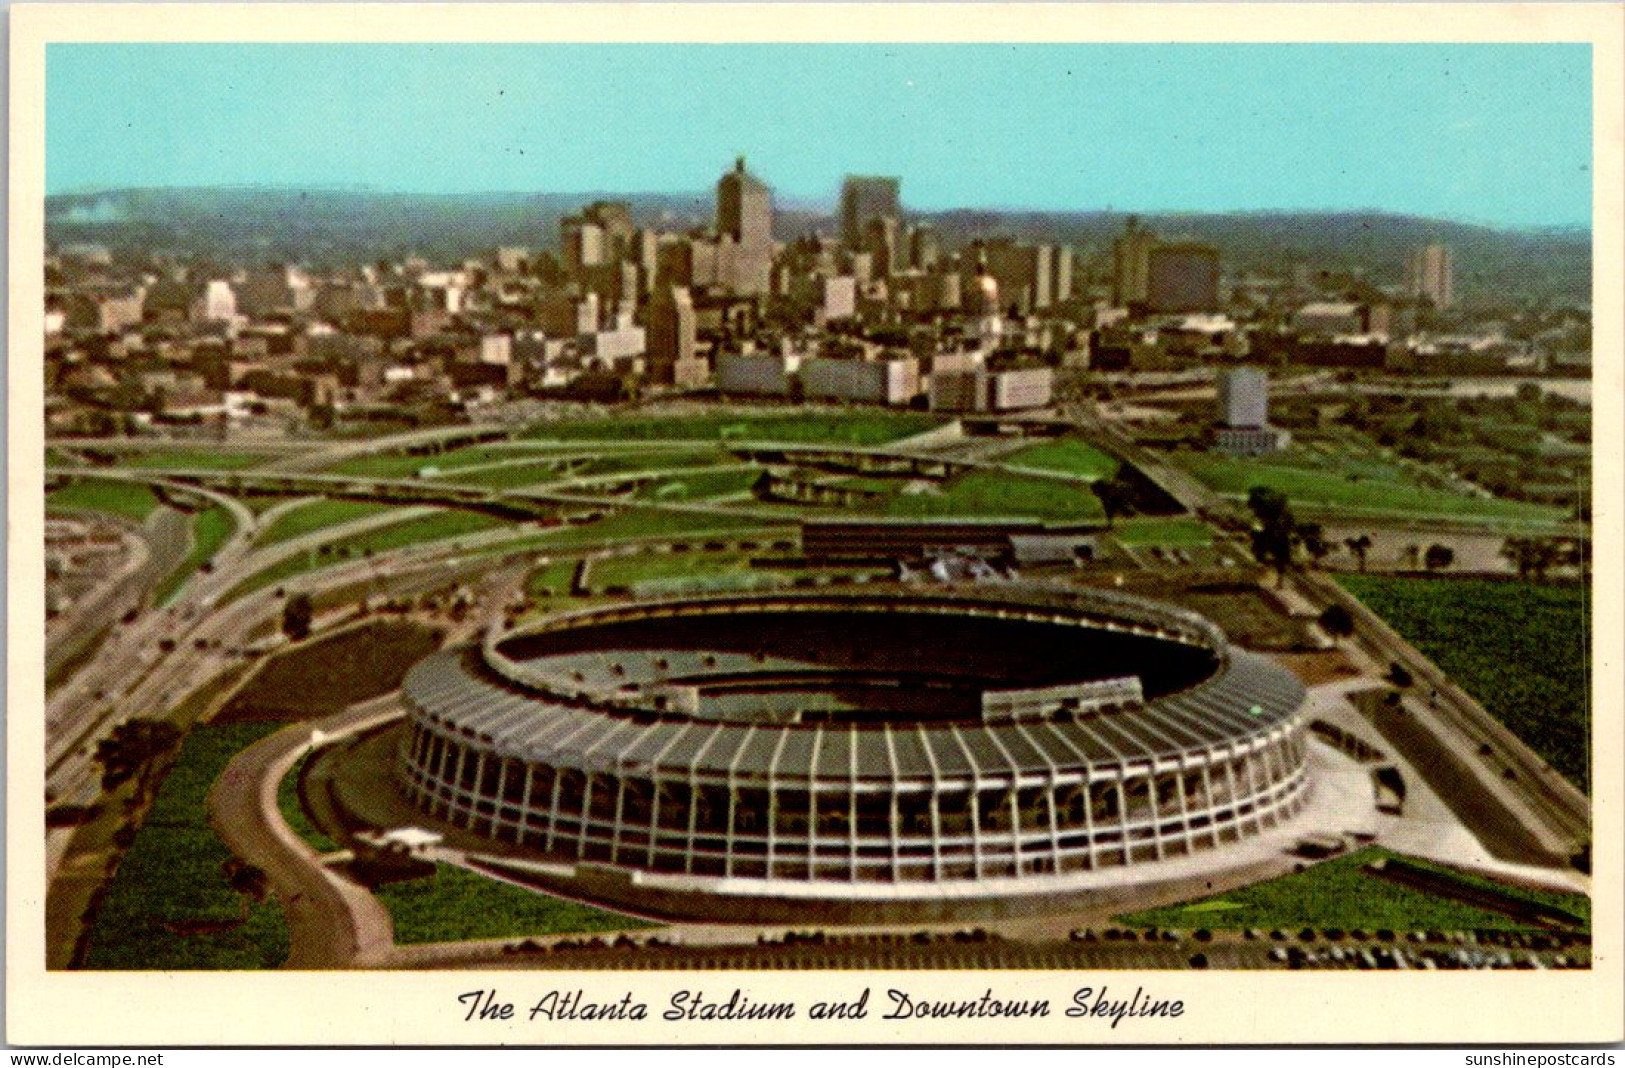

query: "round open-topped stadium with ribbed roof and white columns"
xmin=397 ymin=584 xmax=1310 ymax=909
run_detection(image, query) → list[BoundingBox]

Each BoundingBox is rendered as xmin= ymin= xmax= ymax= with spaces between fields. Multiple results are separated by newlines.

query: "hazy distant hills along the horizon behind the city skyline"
xmin=46 ymin=189 xmax=1591 ymax=304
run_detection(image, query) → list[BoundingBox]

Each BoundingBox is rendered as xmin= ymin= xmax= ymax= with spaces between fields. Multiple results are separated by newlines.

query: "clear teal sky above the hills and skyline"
xmin=46 ymin=44 xmax=1591 ymax=226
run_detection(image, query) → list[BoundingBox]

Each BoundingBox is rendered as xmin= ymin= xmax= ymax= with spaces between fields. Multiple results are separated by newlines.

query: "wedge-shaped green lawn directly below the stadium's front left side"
xmin=374 ymin=865 xmax=657 ymax=944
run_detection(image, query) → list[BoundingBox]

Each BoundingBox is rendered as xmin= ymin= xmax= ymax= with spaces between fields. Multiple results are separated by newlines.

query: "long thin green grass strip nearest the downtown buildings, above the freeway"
xmin=525 ymin=411 xmax=943 ymax=445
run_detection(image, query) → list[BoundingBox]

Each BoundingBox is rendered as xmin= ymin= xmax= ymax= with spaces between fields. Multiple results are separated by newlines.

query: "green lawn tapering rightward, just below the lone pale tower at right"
xmin=1177 ymin=445 xmax=1565 ymax=523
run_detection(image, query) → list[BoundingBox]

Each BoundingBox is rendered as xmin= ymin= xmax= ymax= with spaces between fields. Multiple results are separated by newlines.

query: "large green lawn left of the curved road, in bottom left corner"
xmin=85 ymin=723 xmax=288 ymax=970
